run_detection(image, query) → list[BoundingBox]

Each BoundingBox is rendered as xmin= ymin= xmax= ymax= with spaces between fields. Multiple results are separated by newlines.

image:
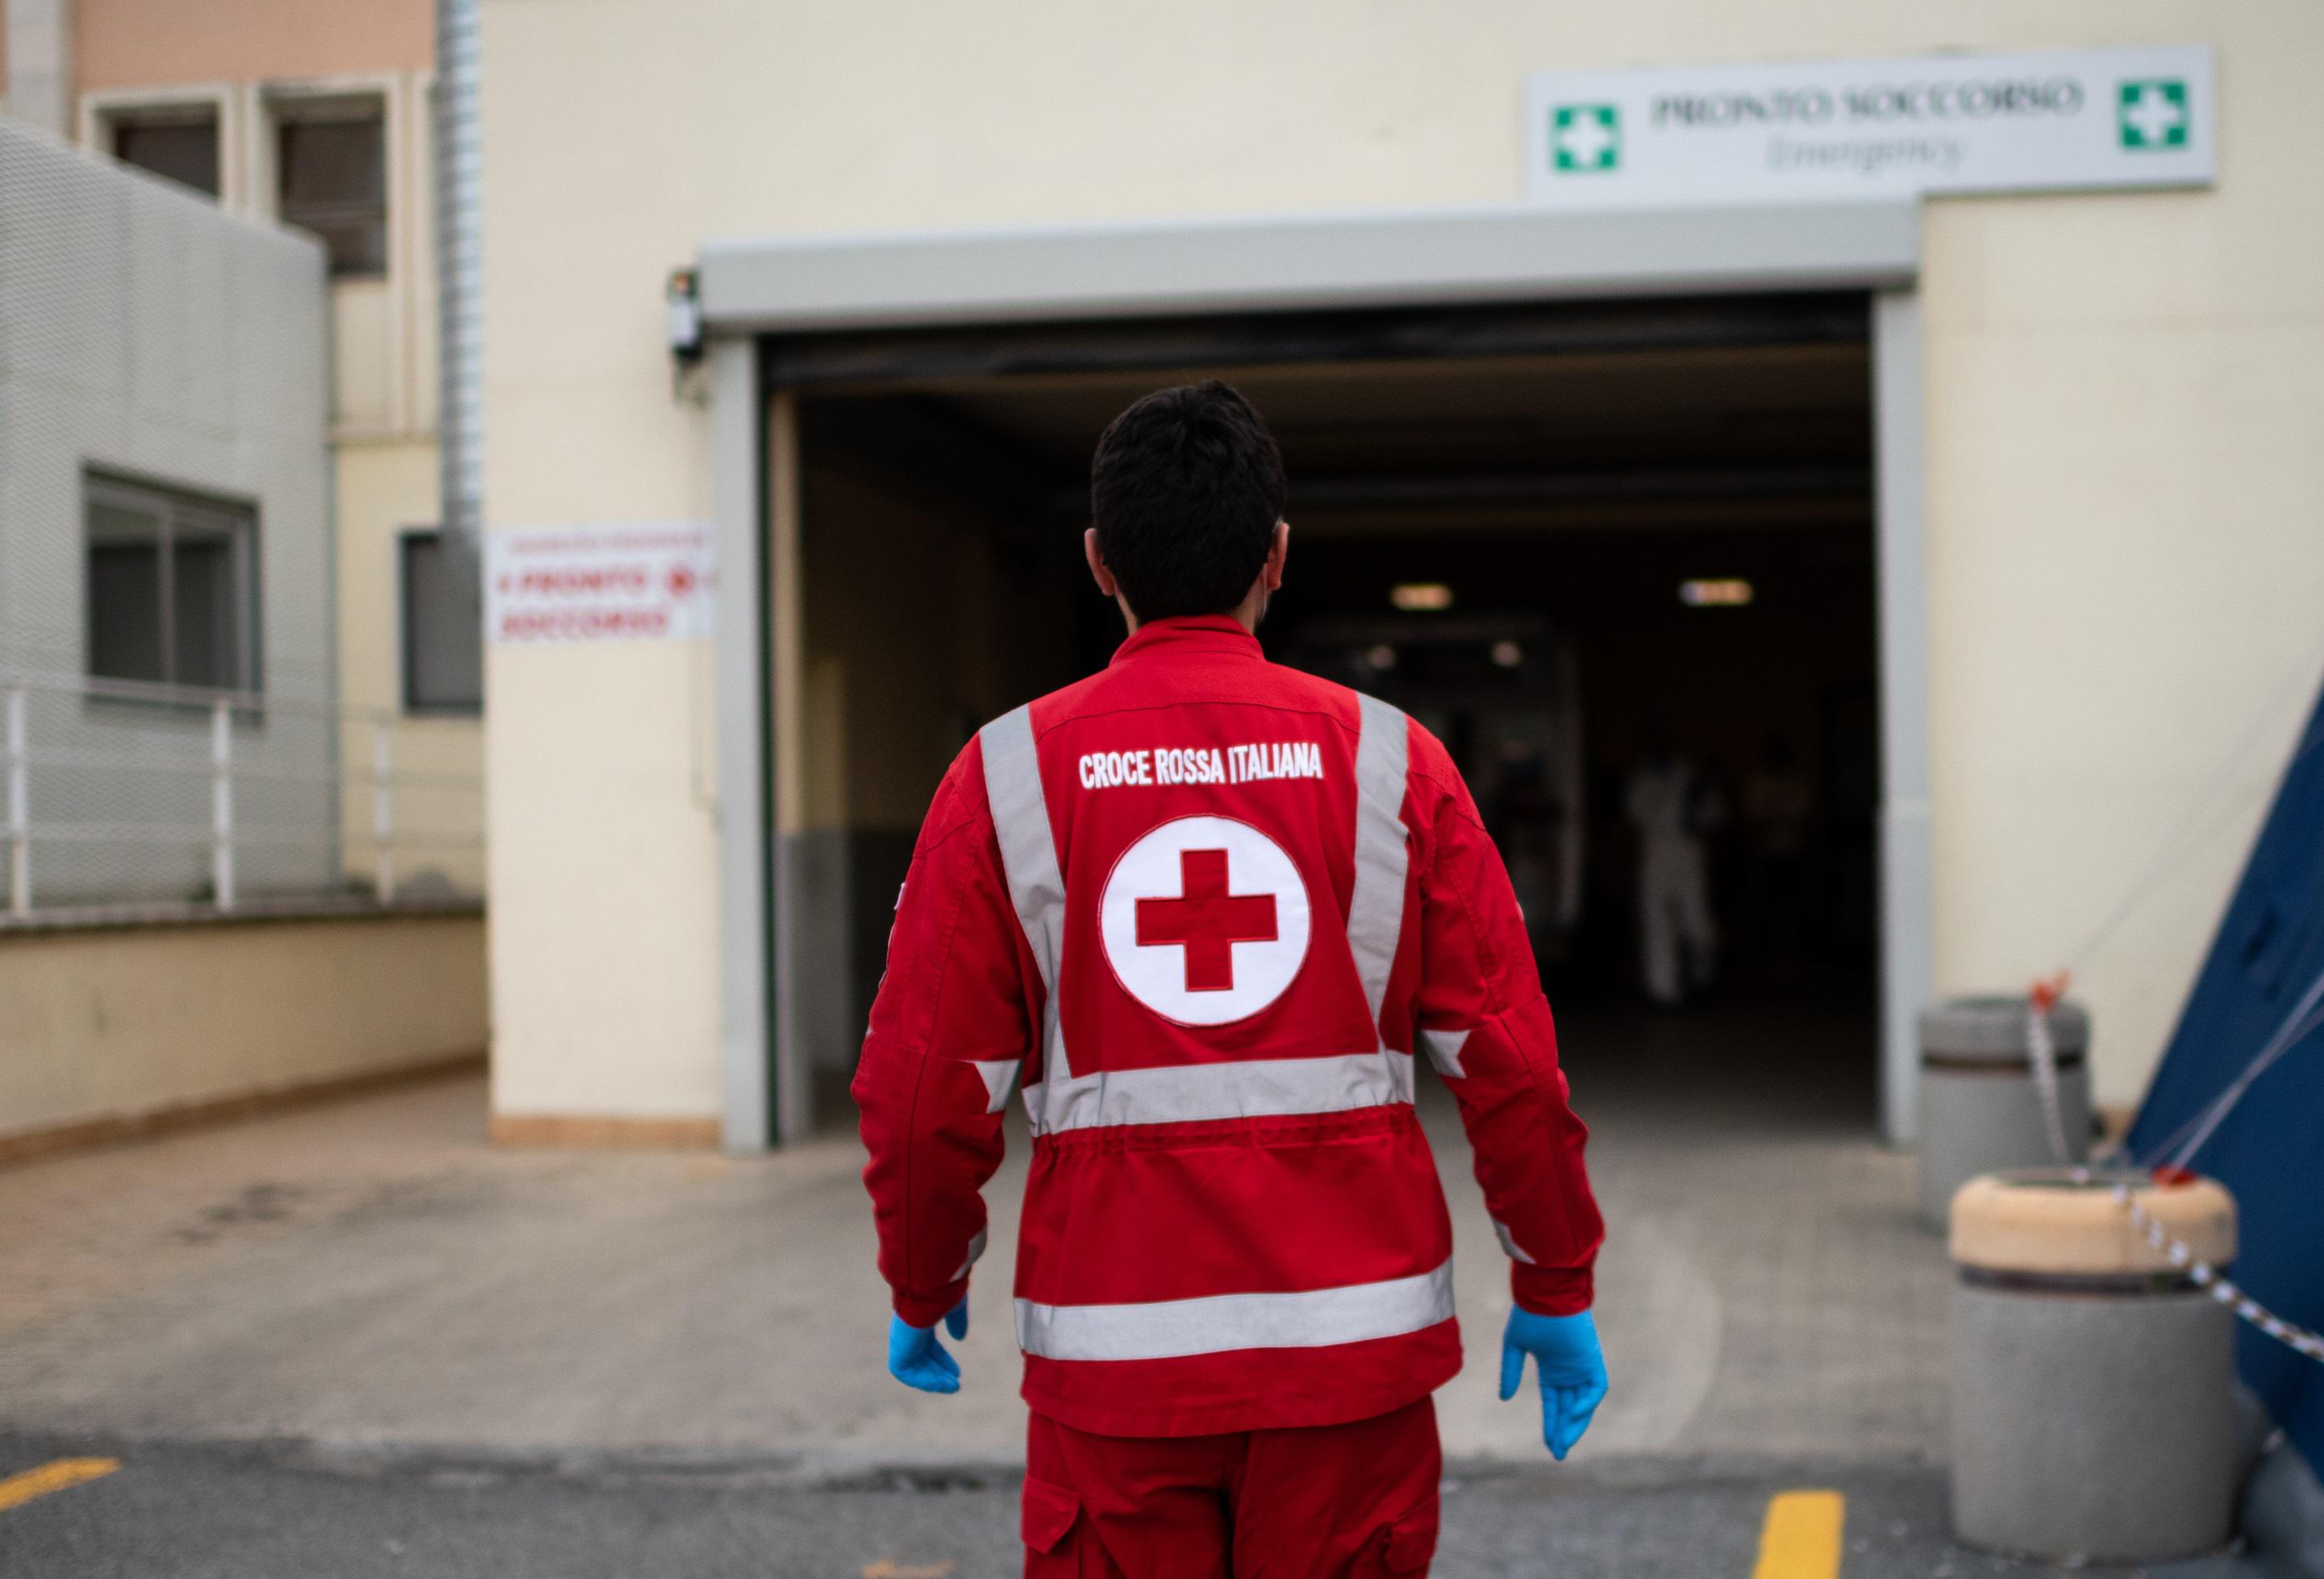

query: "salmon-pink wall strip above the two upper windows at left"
xmin=72 ymin=0 xmax=435 ymax=89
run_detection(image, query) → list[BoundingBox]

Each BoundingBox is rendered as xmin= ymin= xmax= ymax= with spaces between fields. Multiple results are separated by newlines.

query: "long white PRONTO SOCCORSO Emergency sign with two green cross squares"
xmin=1525 ymin=44 xmax=2217 ymax=210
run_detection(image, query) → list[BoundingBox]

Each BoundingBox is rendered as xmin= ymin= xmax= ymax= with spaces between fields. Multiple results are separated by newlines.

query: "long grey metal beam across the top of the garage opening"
xmin=702 ymin=202 xmax=1920 ymax=335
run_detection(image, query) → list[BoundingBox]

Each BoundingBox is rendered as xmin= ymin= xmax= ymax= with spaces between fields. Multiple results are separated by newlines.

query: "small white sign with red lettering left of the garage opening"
xmin=483 ymin=521 xmax=711 ymax=644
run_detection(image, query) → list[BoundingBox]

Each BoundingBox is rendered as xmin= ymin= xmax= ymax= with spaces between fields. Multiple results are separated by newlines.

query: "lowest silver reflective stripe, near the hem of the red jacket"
xmin=1018 ymin=1260 xmax=1452 ymax=1360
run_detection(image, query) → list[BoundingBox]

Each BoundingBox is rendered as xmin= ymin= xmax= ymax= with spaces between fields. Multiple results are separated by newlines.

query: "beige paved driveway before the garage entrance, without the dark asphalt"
xmin=0 ymin=1010 xmax=1947 ymax=1469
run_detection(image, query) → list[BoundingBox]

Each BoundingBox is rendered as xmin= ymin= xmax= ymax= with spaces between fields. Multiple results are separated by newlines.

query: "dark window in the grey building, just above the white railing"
xmin=84 ymin=477 xmax=258 ymax=690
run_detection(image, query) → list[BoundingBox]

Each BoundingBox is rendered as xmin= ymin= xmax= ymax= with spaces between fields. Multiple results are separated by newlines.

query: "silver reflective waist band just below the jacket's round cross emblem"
xmin=1025 ymin=1051 xmax=1413 ymax=1130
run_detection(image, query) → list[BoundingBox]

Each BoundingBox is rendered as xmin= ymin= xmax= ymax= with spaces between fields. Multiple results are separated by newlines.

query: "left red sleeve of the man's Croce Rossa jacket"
xmin=851 ymin=744 xmax=1039 ymax=1328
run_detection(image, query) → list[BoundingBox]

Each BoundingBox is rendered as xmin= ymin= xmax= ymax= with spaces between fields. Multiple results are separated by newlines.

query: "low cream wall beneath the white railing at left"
xmin=0 ymin=916 xmax=485 ymax=1142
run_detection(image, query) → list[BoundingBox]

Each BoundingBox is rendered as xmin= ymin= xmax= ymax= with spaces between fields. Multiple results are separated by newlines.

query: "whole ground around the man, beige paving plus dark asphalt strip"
xmin=0 ymin=1007 xmax=2268 ymax=1579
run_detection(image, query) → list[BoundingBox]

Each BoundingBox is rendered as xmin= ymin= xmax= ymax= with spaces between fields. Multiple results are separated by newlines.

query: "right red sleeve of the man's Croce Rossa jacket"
xmin=1408 ymin=726 xmax=1606 ymax=1316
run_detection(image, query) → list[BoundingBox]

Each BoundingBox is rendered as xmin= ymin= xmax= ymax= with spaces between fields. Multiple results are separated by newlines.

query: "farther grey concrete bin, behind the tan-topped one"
xmin=1920 ymin=998 xmax=2089 ymax=1228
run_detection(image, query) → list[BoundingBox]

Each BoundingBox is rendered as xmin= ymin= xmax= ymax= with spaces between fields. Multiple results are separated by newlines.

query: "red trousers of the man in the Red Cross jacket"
xmin=1025 ymin=1398 xmax=1443 ymax=1579
